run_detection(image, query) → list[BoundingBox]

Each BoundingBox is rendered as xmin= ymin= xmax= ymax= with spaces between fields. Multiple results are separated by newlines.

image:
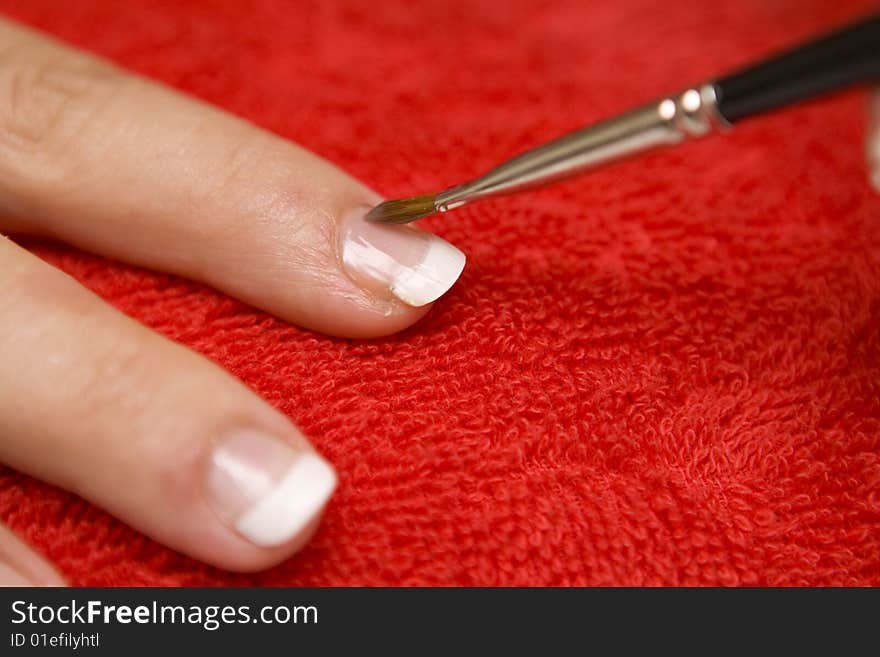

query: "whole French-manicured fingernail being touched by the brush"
xmin=340 ymin=210 xmax=465 ymax=306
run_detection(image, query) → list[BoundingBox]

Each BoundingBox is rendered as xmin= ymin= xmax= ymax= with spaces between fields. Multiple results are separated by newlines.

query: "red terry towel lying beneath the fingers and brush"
xmin=0 ymin=0 xmax=880 ymax=585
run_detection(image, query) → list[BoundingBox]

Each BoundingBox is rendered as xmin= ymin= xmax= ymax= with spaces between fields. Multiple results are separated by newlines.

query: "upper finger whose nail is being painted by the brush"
xmin=0 ymin=22 xmax=465 ymax=337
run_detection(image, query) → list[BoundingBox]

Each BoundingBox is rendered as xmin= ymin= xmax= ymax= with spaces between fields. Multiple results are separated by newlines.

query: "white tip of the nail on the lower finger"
xmin=235 ymin=454 xmax=336 ymax=547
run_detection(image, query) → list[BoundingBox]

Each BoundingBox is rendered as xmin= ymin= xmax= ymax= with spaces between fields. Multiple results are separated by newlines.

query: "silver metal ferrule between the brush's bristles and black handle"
xmin=434 ymin=83 xmax=729 ymax=212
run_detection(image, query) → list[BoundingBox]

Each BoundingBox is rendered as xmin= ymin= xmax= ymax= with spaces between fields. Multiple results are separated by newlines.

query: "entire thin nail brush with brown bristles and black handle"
xmin=367 ymin=15 xmax=880 ymax=224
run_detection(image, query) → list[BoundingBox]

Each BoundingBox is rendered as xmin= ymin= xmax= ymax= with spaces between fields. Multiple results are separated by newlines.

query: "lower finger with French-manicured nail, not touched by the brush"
xmin=0 ymin=238 xmax=336 ymax=570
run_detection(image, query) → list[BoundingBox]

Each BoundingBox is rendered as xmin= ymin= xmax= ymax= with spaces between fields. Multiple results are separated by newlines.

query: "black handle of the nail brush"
xmin=715 ymin=14 xmax=880 ymax=123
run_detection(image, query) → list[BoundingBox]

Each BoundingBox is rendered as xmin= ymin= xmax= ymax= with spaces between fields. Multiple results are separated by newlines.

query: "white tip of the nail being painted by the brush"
xmin=391 ymin=237 xmax=466 ymax=307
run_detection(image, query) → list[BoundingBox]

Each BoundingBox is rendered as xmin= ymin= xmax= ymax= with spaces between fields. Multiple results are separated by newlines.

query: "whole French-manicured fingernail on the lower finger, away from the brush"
xmin=207 ymin=430 xmax=336 ymax=547
